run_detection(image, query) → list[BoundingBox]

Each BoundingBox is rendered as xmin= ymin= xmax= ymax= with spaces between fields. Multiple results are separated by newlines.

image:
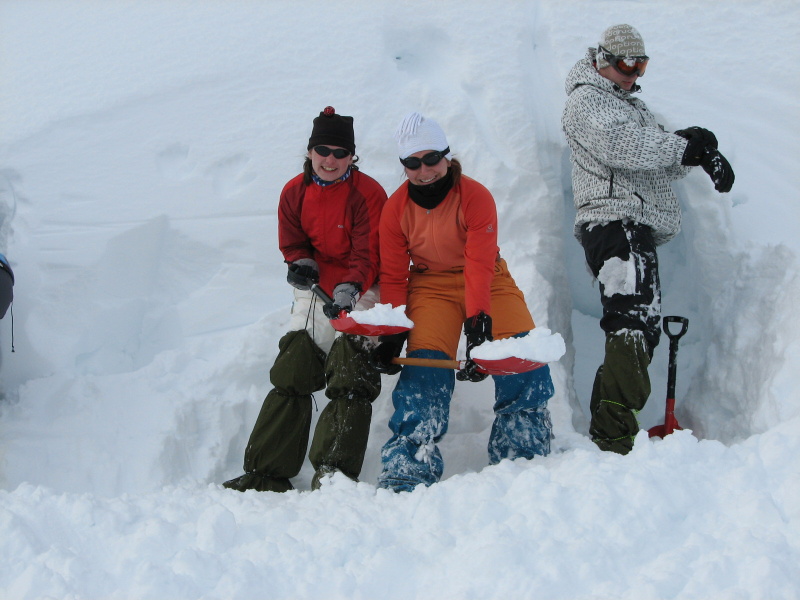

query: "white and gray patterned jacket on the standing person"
xmin=561 ymin=48 xmax=691 ymax=244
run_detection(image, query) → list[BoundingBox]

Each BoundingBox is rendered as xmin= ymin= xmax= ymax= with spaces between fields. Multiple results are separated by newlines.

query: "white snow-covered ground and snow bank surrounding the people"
xmin=0 ymin=0 xmax=800 ymax=600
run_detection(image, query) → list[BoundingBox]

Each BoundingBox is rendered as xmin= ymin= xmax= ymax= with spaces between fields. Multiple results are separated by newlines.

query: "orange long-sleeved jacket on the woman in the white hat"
xmin=380 ymin=175 xmax=499 ymax=317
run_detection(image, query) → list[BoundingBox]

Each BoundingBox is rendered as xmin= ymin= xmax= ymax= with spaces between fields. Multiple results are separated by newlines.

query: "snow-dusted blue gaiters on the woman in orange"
xmin=378 ymin=350 xmax=555 ymax=492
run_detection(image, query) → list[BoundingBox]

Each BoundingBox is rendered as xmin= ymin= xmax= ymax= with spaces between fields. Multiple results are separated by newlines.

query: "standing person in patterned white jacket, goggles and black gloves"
xmin=561 ymin=24 xmax=734 ymax=454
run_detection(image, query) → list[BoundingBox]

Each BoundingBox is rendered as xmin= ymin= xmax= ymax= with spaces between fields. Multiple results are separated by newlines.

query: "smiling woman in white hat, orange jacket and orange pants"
xmin=372 ymin=113 xmax=554 ymax=492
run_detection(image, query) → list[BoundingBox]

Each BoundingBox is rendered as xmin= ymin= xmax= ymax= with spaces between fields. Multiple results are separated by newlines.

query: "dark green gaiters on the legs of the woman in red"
xmin=225 ymin=330 xmax=381 ymax=492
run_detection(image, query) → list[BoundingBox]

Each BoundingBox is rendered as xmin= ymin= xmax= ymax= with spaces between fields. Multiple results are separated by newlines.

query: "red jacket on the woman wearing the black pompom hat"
xmin=278 ymin=170 xmax=386 ymax=294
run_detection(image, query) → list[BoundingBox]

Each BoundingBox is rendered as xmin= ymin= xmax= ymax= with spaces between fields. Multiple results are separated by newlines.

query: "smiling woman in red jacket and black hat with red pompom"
xmin=224 ymin=106 xmax=386 ymax=492
